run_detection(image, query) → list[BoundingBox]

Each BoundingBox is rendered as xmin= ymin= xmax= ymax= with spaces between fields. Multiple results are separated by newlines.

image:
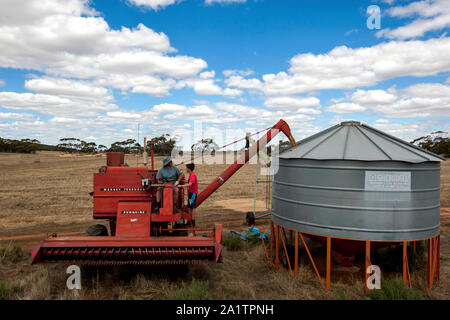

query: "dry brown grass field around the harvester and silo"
xmin=0 ymin=152 xmax=450 ymax=299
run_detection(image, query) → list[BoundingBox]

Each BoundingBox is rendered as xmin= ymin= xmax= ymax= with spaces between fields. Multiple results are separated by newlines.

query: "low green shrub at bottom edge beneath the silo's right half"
xmin=364 ymin=280 xmax=424 ymax=300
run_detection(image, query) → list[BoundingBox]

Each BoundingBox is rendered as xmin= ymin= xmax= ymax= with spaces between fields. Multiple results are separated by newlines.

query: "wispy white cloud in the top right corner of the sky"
xmin=377 ymin=0 xmax=450 ymax=39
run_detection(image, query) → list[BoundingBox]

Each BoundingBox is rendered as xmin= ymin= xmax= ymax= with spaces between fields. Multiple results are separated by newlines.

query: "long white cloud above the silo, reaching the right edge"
xmin=262 ymin=38 xmax=450 ymax=95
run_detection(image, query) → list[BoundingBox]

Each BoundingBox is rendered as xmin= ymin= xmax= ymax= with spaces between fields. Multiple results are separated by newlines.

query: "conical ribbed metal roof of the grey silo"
xmin=280 ymin=121 xmax=445 ymax=163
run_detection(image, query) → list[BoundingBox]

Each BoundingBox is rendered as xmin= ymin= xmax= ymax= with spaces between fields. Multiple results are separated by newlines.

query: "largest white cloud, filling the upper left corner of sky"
xmin=0 ymin=0 xmax=207 ymax=96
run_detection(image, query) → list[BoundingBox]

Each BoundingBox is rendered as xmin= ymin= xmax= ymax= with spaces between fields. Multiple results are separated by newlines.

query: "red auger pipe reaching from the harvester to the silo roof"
xmin=195 ymin=119 xmax=295 ymax=207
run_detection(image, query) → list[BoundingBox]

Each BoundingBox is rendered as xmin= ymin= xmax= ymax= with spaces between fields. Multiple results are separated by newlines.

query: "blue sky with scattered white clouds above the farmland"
xmin=0 ymin=0 xmax=450 ymax=146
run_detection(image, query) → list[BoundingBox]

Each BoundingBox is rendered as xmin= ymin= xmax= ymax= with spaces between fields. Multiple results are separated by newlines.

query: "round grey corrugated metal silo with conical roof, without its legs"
xmin=272 ymin=121 xmax=443 ymax=241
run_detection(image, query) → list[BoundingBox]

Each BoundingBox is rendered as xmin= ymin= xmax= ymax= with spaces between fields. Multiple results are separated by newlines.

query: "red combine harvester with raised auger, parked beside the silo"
xmin=31 ymin=120 xmax=295 ymax=265
